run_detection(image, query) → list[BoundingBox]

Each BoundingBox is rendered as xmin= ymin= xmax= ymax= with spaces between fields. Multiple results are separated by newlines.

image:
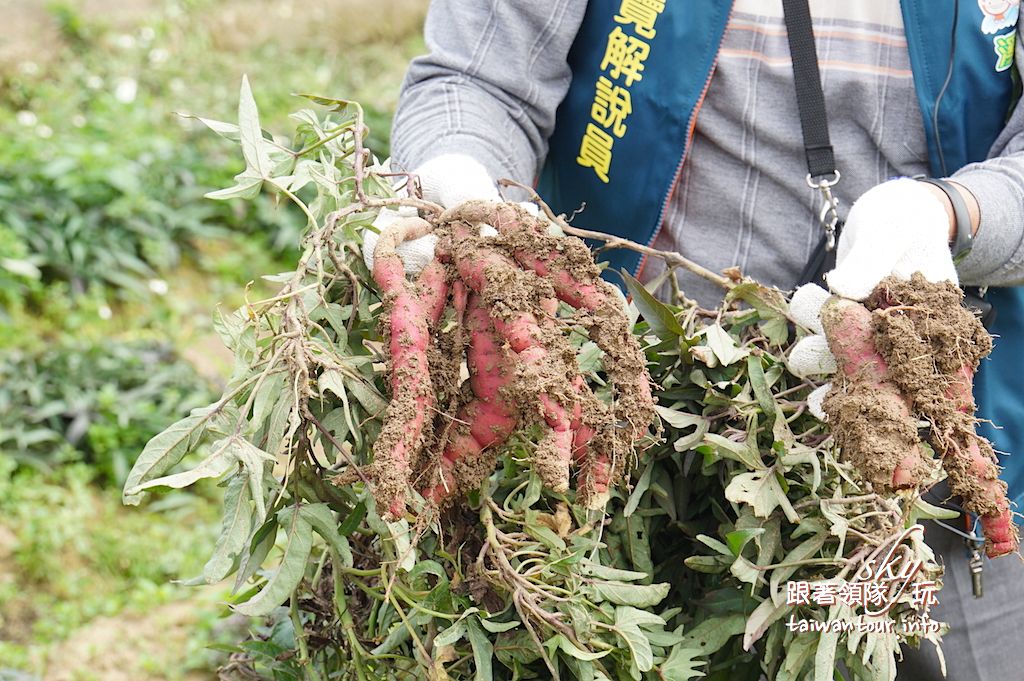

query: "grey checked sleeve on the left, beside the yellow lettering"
xmin=391 ymin=0 xmax=587 ymax=183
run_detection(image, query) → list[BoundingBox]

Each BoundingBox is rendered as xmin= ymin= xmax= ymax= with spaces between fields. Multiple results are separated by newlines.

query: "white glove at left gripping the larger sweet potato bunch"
xmin=362 ymin=154 xmax=501 ymax=275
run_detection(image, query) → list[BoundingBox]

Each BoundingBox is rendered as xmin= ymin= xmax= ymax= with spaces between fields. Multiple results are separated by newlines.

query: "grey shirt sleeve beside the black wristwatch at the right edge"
xmin=951 ymin=23 xmax=1024 ymax=286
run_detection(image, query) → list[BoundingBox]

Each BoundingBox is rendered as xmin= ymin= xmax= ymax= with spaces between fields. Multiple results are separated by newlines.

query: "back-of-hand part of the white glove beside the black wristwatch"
xmin=825 ymin=178 xmax=959 ymax=300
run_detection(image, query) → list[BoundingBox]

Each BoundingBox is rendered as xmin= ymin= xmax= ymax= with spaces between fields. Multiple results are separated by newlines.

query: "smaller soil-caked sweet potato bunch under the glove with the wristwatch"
xmin=821 ymin=274 xmax=1019 ymax=557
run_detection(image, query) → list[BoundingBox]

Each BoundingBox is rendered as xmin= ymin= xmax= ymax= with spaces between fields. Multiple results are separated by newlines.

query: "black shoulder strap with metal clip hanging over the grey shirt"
xmin=782 ymin=0 xmax=842 ymax=286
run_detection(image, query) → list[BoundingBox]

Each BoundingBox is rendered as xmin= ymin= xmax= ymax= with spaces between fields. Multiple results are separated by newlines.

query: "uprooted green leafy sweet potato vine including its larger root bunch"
xmin=119 ymin=83 xmax=1015 ymax=681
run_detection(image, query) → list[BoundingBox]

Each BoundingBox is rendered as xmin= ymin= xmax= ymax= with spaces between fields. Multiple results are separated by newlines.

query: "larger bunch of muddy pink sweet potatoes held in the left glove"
xmin=370 ymin=202 xmax=654 ymax=518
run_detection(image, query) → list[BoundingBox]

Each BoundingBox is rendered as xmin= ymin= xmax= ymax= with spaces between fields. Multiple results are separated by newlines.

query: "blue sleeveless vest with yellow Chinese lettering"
xmin=539 ymin=0 xmax=1024 ymax=503
